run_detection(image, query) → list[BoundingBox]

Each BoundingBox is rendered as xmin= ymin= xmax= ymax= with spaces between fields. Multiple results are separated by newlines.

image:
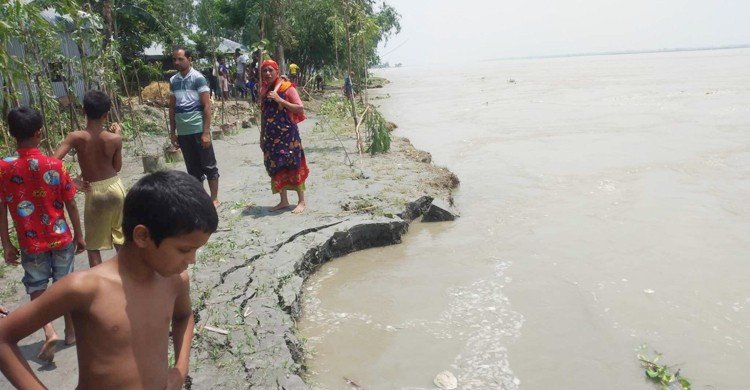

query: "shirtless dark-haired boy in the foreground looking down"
xmin=0 ymin=171 xmax=218 ymax=390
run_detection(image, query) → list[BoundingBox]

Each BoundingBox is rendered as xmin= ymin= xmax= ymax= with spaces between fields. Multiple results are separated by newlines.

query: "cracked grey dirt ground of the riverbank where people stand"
xmin=0 ymin=98 xmax=458 ymax=389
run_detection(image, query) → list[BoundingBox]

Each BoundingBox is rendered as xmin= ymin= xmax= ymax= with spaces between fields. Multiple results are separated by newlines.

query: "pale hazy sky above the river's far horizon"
xmin=380 ymin=0 xmax=750 ymax=66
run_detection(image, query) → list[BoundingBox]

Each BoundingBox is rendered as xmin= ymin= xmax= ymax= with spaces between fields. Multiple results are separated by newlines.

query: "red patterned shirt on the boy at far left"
xmin=0 ymin=148 xmax=76 ymax=253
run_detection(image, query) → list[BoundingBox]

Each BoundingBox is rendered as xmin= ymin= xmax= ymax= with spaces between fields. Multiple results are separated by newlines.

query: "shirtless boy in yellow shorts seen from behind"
xmin=54 ymin=91 xmax=125 ymax=267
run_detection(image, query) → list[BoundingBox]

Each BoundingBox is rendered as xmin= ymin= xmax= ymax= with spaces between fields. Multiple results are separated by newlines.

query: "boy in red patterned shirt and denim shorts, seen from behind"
xmin=0 ymin=107 xmax=86 ymax=361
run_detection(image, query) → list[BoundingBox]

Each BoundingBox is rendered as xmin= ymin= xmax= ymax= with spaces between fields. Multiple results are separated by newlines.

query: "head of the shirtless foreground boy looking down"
xmin=122 ymin=171 xmax=219 ymax=276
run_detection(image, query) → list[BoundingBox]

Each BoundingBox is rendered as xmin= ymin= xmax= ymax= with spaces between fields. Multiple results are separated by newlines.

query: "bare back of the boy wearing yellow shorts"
xmin=55 ymin=129 xmax=122 ymax=182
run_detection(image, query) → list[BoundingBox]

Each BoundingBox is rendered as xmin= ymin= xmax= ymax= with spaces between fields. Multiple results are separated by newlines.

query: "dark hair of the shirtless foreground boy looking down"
xmin=122 ymin=171 xmax=219 ymax=246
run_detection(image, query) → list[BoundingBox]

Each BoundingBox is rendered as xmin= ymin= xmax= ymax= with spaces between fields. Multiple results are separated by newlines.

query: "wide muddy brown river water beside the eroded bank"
xmin=299 ymin=49 xmax=750 ymax=390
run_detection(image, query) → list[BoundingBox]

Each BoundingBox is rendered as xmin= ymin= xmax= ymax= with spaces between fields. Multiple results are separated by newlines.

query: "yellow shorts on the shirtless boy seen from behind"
xmin=83 ymin=176 xmax=125 ymax=250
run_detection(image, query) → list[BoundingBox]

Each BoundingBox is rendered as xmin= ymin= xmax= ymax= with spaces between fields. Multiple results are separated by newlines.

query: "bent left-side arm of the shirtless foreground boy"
xmin=0 ymin=272 xmax=95 ymax=389
